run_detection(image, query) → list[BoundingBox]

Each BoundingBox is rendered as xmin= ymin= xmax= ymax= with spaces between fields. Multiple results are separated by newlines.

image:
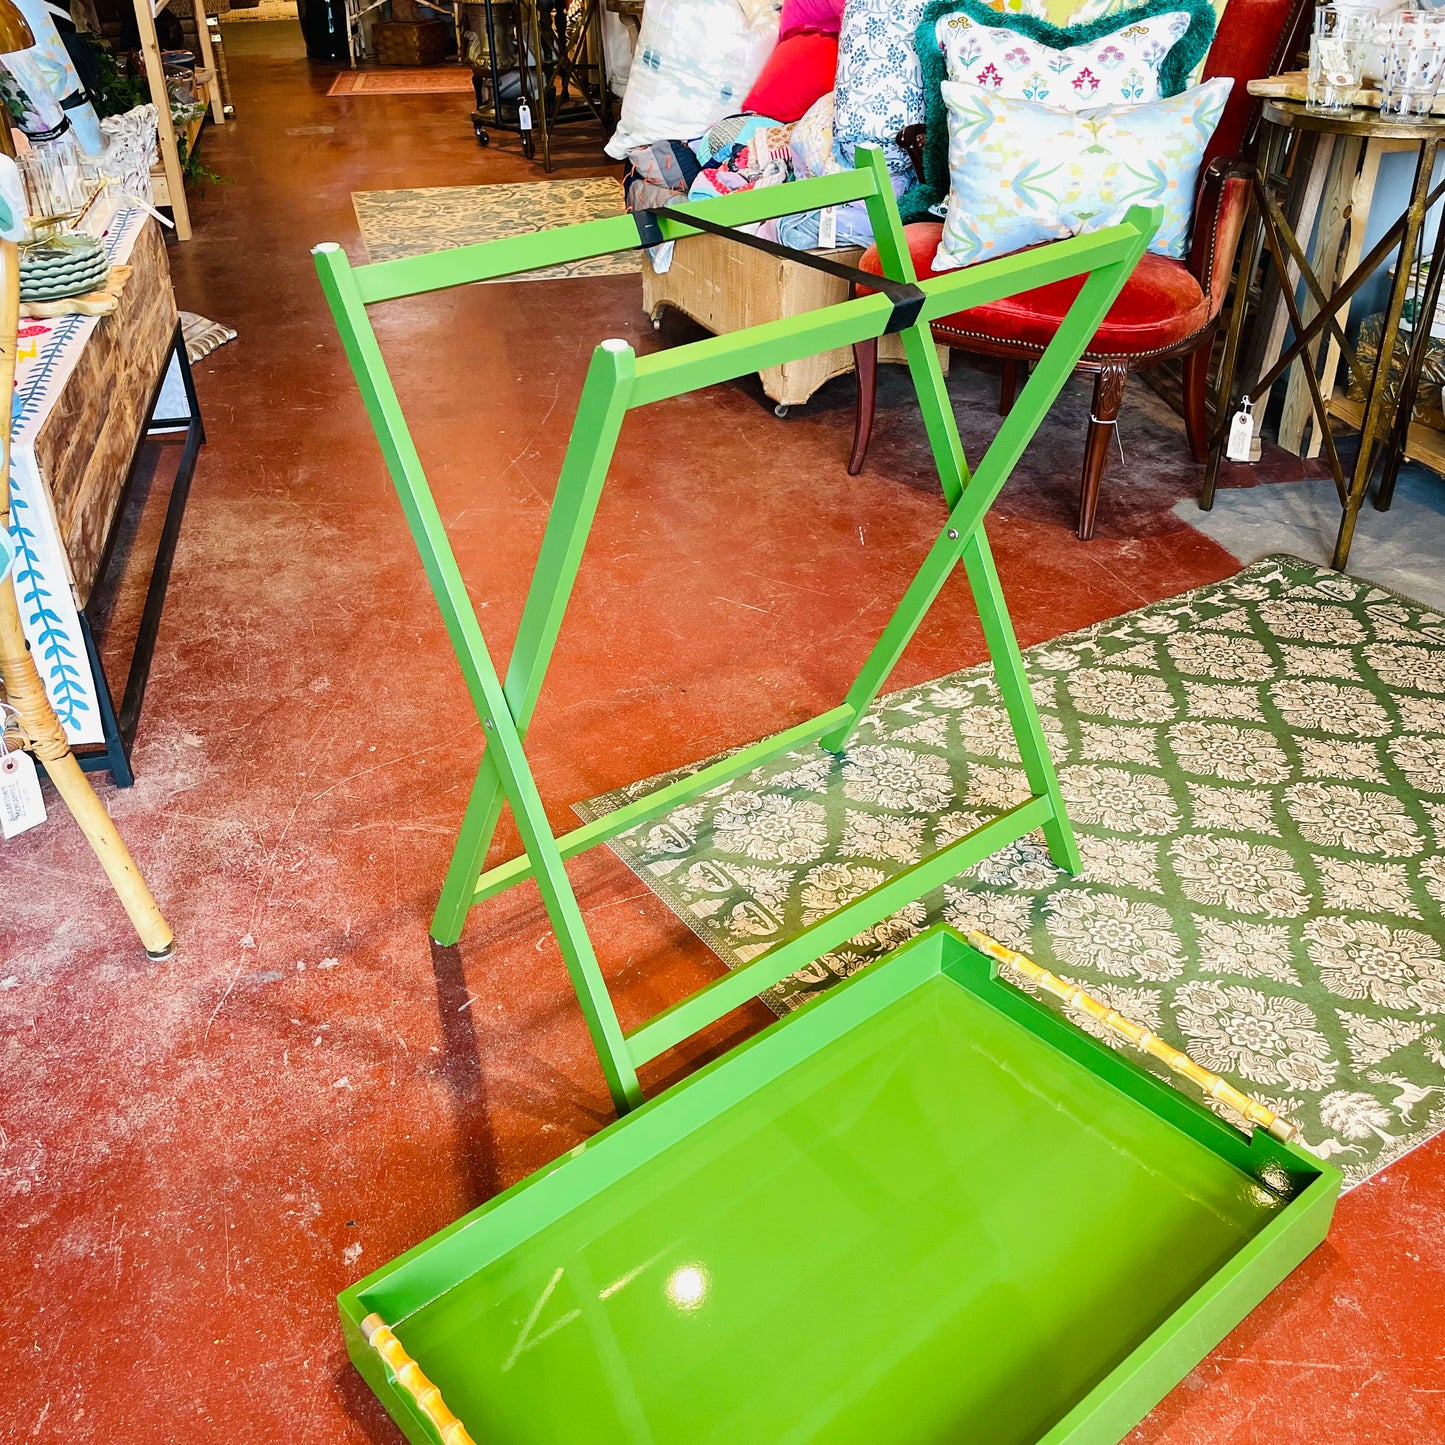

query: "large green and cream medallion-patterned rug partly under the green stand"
xmin=578 ymin=556 xmax=1445 ymax=1183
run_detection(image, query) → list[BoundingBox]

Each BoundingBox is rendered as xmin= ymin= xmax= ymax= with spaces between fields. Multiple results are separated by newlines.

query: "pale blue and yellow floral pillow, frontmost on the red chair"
xmin=933 ymin=78 xmax=1234 ymax=270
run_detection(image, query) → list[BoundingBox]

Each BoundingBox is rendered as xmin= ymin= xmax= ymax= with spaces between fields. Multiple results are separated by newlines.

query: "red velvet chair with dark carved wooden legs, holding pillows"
xmin=848 ymin=0 xmax=1314 ymax=540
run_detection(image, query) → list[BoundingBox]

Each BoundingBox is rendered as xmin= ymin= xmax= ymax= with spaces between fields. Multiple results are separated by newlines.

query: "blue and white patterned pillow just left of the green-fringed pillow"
xmin=834 ymin=0 xmax=928 ymax=175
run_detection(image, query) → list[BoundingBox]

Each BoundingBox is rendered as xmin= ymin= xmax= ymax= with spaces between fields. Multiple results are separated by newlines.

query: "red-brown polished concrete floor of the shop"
xmin=0 ymin=25 xmax=1445 ymax=1445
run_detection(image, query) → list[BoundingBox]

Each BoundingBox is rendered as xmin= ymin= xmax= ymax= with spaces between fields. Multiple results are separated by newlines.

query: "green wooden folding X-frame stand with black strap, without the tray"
xmin=314 ymin=146 xmax=1160 ymax=1111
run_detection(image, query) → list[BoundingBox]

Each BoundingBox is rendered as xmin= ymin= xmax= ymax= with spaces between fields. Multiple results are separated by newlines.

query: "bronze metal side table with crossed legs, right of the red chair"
xmin=1201 ymin=100 xmax=1445 ymax=568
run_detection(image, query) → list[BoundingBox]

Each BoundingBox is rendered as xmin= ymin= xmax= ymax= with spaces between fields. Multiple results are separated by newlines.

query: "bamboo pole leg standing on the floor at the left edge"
xmin=0 ymin=240 xmax=175 ymax=958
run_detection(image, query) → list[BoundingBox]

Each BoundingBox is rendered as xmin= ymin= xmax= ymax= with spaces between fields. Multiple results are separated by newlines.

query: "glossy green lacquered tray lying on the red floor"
xmin=340 ymin=928 xmax=1340 ymax=1445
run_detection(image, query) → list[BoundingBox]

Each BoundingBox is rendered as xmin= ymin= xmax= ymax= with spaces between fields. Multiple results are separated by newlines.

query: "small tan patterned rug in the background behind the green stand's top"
xmin=351 ymin=176 xmax=642 ymax=285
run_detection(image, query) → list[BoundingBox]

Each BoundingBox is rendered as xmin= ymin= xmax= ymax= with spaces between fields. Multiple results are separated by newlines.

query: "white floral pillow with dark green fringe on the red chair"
xmin=899 ymin=0 xmax=1215 ymax=221
